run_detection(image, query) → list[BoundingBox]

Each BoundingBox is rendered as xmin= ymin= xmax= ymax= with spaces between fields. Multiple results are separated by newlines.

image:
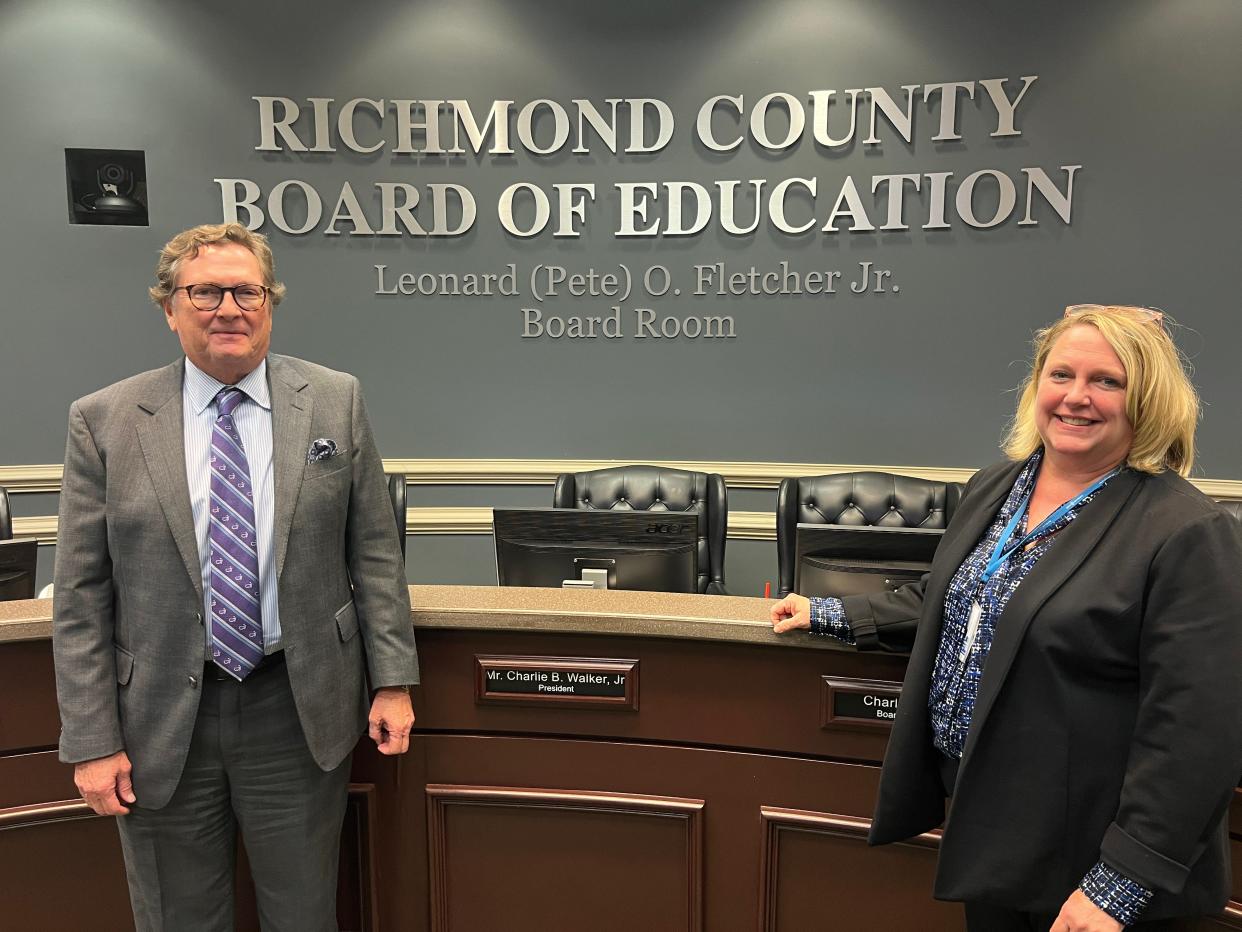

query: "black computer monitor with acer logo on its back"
xmin=492 ymin=508 xmax=698 ymax=593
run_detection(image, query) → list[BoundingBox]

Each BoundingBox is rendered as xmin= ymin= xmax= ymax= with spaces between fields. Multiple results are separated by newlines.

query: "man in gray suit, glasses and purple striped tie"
xmin=53 ymin=224 xmax=419 ymax=932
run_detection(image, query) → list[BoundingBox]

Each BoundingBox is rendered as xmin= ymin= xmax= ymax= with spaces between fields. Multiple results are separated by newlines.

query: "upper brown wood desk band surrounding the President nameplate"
xmin=414 ymin=630 xmax=905 ymax=763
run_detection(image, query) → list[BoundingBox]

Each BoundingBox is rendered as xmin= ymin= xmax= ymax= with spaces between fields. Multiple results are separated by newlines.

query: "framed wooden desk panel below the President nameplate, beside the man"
xmin=426 ymin=784 xmax=703 ymax=932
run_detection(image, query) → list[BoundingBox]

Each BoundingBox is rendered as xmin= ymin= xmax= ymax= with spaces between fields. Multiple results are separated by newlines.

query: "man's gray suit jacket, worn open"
xmin=52 ymin=354 xmax=419 ymax=808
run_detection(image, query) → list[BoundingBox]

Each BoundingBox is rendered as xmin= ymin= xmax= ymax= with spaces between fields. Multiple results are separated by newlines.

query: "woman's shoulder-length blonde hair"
xmin=1001 ymin=306 xmax=1199 ymax=476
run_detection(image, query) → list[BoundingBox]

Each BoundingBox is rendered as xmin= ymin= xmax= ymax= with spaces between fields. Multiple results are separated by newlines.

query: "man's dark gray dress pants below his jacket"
xmin=117 ymin=661 xmax=349 ymax=932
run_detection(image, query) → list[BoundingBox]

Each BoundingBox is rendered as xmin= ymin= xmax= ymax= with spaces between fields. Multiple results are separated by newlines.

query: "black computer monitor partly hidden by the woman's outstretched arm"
xmin=794 ymin=524 xmax=944 ymax=596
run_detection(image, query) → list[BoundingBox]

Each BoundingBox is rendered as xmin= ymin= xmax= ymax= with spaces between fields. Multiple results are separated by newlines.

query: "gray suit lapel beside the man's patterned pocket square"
xmin=267 ymin=355 xmax=313 ymax=579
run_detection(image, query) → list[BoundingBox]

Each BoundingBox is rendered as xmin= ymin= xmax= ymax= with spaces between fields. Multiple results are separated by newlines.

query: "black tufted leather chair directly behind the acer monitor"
xmin=551 ymin=466 xmax=729 ymax=595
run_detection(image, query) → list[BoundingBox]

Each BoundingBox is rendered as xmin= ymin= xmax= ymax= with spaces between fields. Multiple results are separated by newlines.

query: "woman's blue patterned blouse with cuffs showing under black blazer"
xmin=811 ymin=452 xmax=1153 ymax=925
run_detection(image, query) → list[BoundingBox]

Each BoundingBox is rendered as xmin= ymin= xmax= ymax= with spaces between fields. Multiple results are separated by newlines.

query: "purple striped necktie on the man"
xmin=207 ymin=386 xmax=263 ymax=681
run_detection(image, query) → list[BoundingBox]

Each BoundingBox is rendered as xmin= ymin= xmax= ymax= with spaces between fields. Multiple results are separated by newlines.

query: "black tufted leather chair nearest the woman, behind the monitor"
xmin=776 ymin=472 xmax=964 ymax=598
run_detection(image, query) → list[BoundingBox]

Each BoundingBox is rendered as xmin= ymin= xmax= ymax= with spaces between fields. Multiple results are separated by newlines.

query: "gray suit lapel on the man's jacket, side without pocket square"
xmin=138 ymin=360 xmax=202 ymax=600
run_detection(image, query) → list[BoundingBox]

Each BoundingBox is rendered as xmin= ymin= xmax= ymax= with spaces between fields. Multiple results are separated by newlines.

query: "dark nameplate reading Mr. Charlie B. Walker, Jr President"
xmin=474 ymin=654 xmax=638 ymax=710
